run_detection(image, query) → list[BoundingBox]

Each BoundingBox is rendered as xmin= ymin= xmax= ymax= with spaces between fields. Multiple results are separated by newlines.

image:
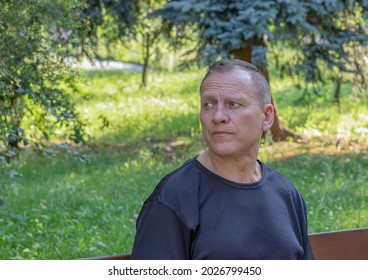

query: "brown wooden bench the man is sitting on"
xmin=88 ymin=228 xmax=368 ymax=260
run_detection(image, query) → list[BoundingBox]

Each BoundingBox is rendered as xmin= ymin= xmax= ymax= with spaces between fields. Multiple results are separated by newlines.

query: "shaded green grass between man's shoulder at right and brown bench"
xmin=269 ymin=154 xmax=368 ymax=232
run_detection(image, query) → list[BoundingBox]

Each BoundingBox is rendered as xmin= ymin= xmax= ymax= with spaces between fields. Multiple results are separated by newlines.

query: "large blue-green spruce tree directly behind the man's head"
xmin=154 ymin=0 xmax=368 ymax=140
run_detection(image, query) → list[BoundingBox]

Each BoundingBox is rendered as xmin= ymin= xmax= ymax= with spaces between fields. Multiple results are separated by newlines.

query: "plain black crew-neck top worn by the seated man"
xmin=132 ymin=158 xmax=313 ymax=260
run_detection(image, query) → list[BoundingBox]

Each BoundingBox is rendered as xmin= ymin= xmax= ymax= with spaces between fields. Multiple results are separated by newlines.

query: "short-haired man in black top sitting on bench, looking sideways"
xmin=132 ymin=60 xmax=313 ymax=259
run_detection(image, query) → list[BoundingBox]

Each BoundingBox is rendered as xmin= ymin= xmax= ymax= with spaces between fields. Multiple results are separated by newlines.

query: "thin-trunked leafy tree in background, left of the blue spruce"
xmin=83 ymin=0 xmax=164 ymax=86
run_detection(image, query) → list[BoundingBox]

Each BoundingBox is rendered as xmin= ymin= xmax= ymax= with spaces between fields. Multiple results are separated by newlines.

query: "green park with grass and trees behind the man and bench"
xmin=0 ymin=0 xmax=368 ymax=260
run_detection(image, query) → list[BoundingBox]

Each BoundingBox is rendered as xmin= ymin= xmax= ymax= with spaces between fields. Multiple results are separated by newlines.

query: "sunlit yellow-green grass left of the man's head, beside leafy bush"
xmin=73 ymin=71 xmax=200 ymax=146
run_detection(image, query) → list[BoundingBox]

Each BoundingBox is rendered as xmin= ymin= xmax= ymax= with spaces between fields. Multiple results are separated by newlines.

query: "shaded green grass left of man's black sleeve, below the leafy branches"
xmin=0 ymin=153 xmax=180 ymax=259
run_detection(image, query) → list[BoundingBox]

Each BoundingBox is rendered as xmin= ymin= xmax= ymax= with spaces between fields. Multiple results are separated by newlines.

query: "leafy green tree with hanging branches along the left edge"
xmin=0 ymin=0 xmax=90 ymax=175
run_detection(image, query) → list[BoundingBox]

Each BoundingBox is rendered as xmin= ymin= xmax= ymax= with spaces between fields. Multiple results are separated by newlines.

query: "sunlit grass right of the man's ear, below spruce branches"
xmin=273 ymin=78 xmax=368 ymax=141
